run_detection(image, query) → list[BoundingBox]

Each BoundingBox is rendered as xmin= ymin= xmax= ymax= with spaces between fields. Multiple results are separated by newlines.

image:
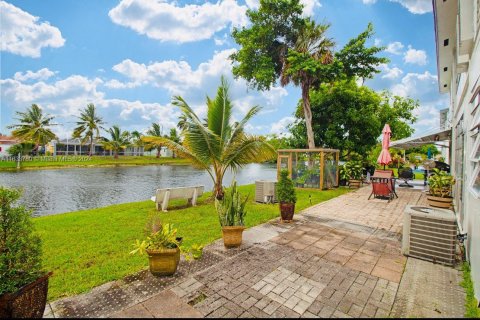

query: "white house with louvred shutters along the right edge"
xmin=433 ymin=0 xmax=480 ymax=300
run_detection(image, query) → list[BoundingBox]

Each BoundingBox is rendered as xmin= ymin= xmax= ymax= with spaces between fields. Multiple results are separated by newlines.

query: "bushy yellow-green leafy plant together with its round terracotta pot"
xmin=130 ymin=215 xmax=182 ymax=276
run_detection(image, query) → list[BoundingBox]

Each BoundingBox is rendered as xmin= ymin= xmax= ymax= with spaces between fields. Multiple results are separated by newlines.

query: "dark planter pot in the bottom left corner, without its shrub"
xmin=0 ymin=272 xmax=52 ymax=319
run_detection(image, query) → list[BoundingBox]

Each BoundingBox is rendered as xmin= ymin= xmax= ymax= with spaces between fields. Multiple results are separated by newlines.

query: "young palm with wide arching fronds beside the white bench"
xmin=144 ymin=77 xmax=275 ymax=199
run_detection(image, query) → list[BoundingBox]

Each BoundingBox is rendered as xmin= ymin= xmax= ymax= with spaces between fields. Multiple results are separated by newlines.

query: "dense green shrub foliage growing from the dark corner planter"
xmin=0 ymin=187 xmax=42 ymax=295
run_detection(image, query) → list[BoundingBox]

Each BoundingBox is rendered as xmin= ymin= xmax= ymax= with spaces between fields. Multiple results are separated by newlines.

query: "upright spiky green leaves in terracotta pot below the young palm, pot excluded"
xmin=215 ymin=181 xmax=248 ymax=227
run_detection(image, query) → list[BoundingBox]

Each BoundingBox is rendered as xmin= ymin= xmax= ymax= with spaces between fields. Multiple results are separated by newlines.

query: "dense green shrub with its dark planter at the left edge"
xmin=0 ymin=187 xmax=52 ymax=319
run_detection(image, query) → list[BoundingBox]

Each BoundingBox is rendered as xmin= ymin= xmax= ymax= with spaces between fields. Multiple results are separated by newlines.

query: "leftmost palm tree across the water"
xmin=7 ymin=104 xmax=57 ymax=151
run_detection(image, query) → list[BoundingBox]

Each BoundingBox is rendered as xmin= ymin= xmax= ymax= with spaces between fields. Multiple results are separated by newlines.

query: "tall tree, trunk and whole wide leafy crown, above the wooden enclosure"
xmin=231 ymin=0 xmax=388 ymax=148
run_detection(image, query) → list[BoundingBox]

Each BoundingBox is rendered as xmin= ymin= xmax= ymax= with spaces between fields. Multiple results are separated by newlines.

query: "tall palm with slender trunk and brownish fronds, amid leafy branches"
xmin=280 ymin=19 xmax=335 ymax=149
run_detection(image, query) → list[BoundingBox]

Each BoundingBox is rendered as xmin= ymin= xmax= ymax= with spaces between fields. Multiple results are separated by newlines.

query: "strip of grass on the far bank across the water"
xmin=0 ymin=156 xmax=188 ymax=170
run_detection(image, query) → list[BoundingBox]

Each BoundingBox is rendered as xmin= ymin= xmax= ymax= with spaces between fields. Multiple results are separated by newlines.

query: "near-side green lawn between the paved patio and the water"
xmin=33 ymin=185 xmax=349 ymax=301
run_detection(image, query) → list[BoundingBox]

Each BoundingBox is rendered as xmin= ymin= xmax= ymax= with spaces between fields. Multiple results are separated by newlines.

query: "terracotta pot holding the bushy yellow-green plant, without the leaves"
xmin=146 ymin=248 xmax=180 ymax=277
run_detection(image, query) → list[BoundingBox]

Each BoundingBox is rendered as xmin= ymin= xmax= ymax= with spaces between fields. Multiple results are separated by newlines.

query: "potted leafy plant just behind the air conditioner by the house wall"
xmin=427 ymin=168 xmax=455 ymax=208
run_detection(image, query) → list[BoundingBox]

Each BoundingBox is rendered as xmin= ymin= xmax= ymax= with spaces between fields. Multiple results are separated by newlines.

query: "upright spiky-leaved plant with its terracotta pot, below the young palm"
xmin=215 ymin=181 xmax=248 ymax=248
